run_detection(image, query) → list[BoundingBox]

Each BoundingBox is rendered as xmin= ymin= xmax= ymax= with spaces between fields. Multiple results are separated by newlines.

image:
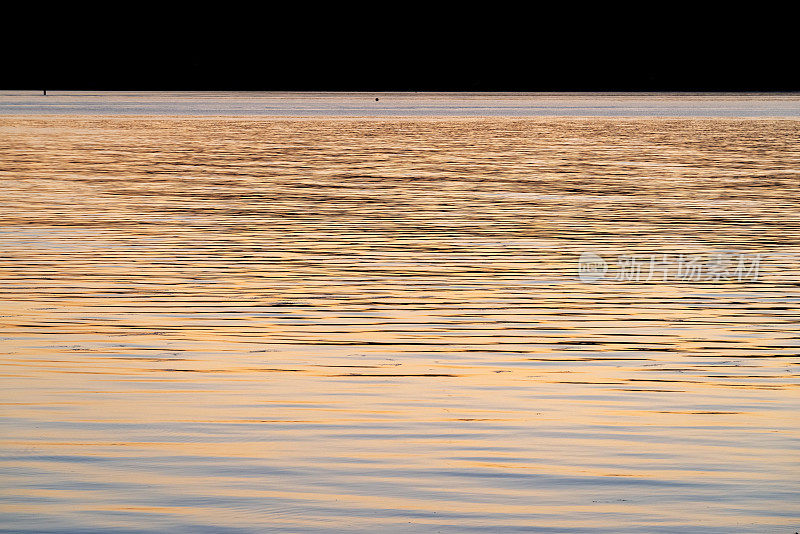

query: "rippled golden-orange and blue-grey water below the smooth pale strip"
xmin=0 ymin=93 xmax=800 ymax=534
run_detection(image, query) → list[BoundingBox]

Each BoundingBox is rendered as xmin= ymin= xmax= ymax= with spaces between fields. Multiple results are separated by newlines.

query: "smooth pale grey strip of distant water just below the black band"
xmin=0 ymin=89 xmax=800 ymax=118
